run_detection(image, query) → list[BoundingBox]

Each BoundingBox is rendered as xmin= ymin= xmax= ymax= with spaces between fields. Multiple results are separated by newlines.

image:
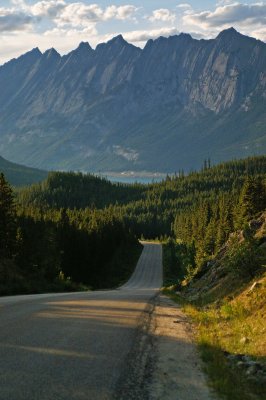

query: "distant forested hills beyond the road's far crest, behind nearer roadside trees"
xmin=18 ymin=156 xmax=266 ymax=238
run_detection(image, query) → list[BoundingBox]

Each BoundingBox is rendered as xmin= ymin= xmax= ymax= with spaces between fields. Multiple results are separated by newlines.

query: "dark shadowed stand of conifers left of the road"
xmin=0 ymin=174 xmax=141 ymax=294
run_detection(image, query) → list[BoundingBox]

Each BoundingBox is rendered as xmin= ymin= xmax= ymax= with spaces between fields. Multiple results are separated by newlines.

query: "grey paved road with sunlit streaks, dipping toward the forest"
xmin=0 ymin=244 xmax=162 ymax=400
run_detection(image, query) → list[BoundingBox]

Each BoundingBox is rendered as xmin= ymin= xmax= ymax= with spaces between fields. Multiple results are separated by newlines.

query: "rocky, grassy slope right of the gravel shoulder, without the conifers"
xmin=165 ymin=216 xmax=266 ymax=400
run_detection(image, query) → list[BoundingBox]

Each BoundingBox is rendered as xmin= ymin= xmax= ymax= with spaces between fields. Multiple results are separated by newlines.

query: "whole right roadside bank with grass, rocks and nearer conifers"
xmin=163 ymin=177 xmax=266 ymax=400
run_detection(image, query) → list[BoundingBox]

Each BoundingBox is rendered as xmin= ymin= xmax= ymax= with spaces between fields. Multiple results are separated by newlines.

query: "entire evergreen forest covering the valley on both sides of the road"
xmin=0 ymin=156 xmax=266 ymax=294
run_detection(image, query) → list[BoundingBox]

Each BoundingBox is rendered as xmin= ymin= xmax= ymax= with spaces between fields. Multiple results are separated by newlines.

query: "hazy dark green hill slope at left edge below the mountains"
xmin=0 ymin=156 xmax=48 ymax=186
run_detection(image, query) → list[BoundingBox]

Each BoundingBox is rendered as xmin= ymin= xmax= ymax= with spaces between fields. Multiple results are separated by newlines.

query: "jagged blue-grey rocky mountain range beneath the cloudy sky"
xmin=0 ymin=28 xmax=266 ymax=172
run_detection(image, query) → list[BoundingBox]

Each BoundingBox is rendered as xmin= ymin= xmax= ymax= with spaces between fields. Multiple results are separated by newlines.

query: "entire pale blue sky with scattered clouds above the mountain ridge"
xmin=0 ymin=0 xmax=266 ymax=64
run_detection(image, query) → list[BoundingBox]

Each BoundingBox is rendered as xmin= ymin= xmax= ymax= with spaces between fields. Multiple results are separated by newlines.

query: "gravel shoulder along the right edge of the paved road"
xmin=150 ymin=294 xmax=217 ymax=400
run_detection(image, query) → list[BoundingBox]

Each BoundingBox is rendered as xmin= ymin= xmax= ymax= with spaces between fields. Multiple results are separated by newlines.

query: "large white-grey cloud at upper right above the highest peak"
xmin=183 ymin=3 xmax=266 ymax=29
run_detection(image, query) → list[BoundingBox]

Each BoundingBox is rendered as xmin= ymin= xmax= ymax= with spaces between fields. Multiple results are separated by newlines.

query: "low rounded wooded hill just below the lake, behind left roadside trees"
xmin=19 ymin=172 xmax=147 ymax=209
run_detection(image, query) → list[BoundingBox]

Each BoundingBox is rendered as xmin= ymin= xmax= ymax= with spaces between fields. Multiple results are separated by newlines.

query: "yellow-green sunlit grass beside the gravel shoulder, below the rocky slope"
xmin=165 ymin=273 xmax=266 ymax=400
